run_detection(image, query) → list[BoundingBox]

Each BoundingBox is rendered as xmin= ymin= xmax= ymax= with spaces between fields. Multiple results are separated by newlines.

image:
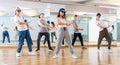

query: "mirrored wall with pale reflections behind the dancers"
xmin=0 ymin=12 xmax=120 ymax=45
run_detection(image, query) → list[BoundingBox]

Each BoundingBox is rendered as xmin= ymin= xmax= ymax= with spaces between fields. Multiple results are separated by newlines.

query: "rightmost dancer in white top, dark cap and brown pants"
xmin=96 ymin=13 xmax=111 ymax=51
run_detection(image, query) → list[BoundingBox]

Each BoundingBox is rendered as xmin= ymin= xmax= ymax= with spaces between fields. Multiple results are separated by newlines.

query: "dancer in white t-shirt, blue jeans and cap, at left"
xmin=14 ymin=8 xmax=35 ymax=57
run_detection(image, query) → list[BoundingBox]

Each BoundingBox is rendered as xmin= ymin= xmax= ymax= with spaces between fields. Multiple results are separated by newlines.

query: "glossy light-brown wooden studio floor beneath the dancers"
xmin=0 ymin=47 xmax=120 ymax=65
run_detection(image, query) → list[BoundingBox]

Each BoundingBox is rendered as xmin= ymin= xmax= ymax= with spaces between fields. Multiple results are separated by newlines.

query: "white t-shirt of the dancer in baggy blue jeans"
xmin=14 ymin=16 xmax=28 ymax=31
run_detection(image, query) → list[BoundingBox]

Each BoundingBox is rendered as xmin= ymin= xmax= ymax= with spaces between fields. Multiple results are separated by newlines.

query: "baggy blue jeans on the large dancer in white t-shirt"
xmin=17 ymin=30 xmax=32 ymax=53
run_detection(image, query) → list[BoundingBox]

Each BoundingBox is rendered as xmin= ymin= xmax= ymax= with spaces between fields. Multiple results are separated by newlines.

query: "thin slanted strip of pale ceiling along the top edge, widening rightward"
xmin=19 ymin=0 xmax=120 ymax=9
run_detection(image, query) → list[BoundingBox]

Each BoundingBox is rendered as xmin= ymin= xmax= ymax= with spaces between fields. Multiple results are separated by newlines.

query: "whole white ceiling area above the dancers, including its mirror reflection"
xmin=0 ymin=0 xmax=119 ymax=16
